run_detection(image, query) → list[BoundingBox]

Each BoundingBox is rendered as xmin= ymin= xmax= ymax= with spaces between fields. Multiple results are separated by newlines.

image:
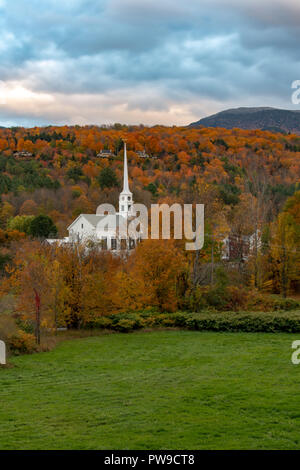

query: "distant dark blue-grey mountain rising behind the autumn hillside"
xmin=190 ymin=108 xmax=300 ymax=134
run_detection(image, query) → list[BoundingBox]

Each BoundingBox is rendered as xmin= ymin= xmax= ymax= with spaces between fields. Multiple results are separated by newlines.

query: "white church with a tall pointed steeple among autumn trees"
xmin=47 ymin=141 xmax=140 ymax=251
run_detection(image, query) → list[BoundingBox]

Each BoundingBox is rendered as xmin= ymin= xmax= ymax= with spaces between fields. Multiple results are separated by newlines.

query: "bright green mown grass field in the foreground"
xmin=0 ymin=331 xmax=300 ymax=450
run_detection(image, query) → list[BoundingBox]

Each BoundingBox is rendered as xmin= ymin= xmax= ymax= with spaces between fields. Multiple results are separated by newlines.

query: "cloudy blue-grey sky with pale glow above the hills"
xmin=0 ymin=0 xmax=300 ymax=126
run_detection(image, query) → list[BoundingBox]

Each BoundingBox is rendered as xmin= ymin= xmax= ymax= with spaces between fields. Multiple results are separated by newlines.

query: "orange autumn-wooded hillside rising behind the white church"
xmin=0 ymin=126 xmax=300 ymax=236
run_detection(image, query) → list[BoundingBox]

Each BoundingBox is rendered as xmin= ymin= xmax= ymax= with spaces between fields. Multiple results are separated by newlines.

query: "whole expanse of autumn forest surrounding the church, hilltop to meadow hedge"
xmin=0 ymin=124 xmax=300 ymax=338
